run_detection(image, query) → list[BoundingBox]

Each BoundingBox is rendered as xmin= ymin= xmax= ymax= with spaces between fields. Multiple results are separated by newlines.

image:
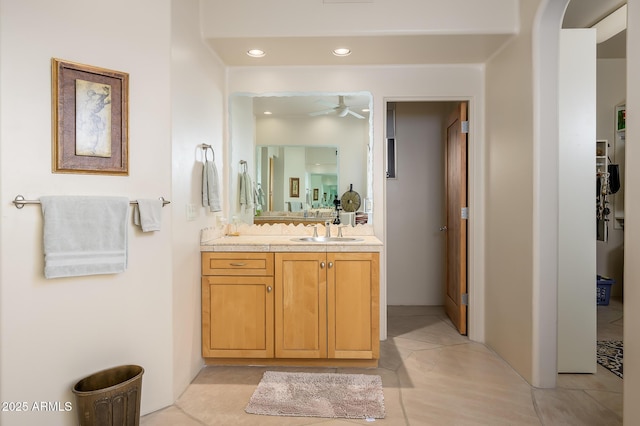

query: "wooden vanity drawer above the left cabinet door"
xmin=202 ymin=252 xmax=273 ymax=276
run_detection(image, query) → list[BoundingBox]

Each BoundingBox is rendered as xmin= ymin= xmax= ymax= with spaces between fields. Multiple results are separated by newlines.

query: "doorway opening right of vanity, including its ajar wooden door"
xmin=385 ymin=100 xmax=468 ymax=334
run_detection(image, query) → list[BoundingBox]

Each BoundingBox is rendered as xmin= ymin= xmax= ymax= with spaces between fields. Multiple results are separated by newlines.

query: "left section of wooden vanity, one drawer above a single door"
xmin=202 ymin=252 xmax=274 ymax=358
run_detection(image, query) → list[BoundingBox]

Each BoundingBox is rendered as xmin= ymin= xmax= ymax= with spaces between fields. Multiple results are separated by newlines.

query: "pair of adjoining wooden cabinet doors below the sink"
xmin=275 ymin=252 xmax=380 ymax=359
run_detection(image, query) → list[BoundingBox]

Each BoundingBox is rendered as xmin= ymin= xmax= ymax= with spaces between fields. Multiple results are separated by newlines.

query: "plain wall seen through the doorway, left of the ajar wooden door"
xmin=386 ymin=102 xmax=449 ymax=305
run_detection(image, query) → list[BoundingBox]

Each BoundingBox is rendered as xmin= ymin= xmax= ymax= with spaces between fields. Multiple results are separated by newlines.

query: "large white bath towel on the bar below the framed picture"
xmin=40 ymin=196 xmax=129 ymax=278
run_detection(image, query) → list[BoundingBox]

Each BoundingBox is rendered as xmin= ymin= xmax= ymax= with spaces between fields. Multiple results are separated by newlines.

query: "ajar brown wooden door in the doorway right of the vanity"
xmin=445 ymin=102 xmax=468 ymax=334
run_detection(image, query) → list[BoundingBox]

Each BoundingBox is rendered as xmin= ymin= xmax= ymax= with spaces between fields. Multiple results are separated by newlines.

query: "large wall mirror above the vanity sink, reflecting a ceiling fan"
xmin=229 ymin=92 xmax=373 ymax=223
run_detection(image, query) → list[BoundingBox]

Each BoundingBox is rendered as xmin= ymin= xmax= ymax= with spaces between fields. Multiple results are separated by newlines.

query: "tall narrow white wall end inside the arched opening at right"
xmin=558 ymin=29 xmax=596 ymax=373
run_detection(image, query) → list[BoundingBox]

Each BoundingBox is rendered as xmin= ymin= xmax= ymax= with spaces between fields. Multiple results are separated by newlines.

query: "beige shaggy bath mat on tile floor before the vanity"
xmin=245 ymin=371 xmax=385 ymax=419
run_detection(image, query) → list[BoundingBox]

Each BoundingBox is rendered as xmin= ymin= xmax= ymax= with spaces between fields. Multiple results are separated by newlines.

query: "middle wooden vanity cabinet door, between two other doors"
xmin=275 ymin=253 xmax=327 ymax=358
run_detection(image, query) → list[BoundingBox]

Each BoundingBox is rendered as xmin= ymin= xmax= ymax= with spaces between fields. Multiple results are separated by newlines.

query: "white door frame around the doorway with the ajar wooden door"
xmin=379 ymin=95 xmax=485 ymax=343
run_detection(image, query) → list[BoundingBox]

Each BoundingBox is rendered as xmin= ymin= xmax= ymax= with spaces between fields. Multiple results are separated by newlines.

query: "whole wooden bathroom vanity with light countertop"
xmin=201 ymin=231 xmax=382 ymax=367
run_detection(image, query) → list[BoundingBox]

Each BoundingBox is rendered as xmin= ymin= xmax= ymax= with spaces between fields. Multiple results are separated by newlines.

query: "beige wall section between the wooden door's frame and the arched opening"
xmin=484 ymin=1 xmax=540 ymax=382
